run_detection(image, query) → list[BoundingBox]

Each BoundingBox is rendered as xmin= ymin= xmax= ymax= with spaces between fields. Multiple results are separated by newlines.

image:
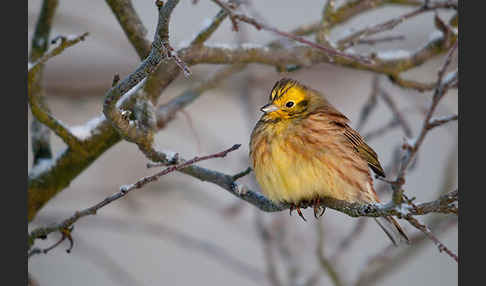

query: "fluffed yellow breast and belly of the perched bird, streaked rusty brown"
xmin=250 ymin=119 xmax=372 ymax=204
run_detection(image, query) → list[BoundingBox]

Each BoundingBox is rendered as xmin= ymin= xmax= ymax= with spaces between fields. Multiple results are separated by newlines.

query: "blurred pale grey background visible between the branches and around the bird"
xmin=28 ymin=0 xmax=458 ymax=286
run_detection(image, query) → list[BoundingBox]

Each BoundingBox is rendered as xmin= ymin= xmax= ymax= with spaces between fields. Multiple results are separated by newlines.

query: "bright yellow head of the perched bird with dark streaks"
xmin=261 ymin=78 xmax=316 ymax=120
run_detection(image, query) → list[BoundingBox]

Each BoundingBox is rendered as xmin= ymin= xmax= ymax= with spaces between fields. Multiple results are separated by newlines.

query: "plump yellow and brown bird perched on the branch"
xmin=249 ymin=78 xmax=409 ymax=245
